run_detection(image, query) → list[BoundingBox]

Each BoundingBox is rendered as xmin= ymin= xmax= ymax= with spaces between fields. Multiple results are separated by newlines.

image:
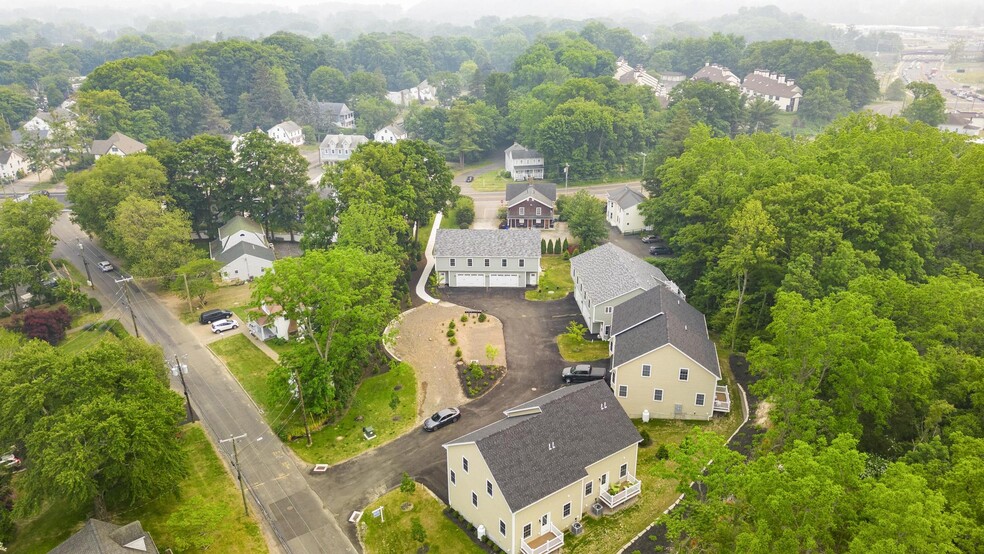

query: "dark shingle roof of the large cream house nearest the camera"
xmin=444 ymin=381 xmax=642 ymax=512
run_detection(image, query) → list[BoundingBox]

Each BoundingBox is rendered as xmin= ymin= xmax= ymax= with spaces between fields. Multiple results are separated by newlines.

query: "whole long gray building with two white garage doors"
xmin=434 ymin=229 xmax=540 ymax=287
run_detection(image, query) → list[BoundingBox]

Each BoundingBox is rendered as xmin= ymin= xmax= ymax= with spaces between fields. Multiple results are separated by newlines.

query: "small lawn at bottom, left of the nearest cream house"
xmin=362 ymin=484 xmax=483 ymax=554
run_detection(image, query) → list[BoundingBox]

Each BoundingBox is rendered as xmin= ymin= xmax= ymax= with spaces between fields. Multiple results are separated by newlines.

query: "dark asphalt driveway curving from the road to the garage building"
xmin=308 ymin=289 xmax=580 ymax=542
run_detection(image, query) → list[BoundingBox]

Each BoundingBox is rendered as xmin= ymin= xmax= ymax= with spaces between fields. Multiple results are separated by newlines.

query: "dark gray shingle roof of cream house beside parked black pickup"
xmin=612 ymin=286 xmax=721 ymax=379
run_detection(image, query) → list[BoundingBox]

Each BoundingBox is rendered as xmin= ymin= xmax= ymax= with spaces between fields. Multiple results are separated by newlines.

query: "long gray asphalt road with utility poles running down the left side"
xmin=53 ymin=211 xmax=356 ymax=554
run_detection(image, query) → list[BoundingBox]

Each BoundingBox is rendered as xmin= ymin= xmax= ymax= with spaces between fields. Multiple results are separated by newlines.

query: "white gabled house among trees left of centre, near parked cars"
xmin=208 ymin=215 xmax=276 ymax=281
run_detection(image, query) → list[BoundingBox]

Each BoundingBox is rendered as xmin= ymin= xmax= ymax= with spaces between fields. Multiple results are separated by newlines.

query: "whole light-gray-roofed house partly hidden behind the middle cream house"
xmin=571 ymin=242 xmax=683 ymax=339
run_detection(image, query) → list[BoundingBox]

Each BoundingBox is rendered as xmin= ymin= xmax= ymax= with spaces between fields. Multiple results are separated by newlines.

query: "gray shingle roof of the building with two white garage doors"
xmin=434 ymin=229 xmax=540 ymax=258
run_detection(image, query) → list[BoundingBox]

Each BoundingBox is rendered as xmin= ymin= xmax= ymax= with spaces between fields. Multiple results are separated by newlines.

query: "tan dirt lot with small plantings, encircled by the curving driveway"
xmin=393 ymin=302 xmax=506 ymax=420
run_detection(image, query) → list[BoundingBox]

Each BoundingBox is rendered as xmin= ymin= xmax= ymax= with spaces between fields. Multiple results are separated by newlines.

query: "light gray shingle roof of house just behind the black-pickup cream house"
xmin=571 ymin=242 xmax=669 ymax=305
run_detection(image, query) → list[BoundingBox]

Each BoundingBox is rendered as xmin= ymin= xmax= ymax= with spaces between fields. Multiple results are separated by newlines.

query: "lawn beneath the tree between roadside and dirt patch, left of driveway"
xmin=288 ymin=363 xmax=417 ymax=464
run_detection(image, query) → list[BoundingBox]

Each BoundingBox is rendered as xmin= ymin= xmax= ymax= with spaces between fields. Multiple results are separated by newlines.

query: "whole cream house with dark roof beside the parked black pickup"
xmin=609 ymin=286 xmax=731 ymax=420
